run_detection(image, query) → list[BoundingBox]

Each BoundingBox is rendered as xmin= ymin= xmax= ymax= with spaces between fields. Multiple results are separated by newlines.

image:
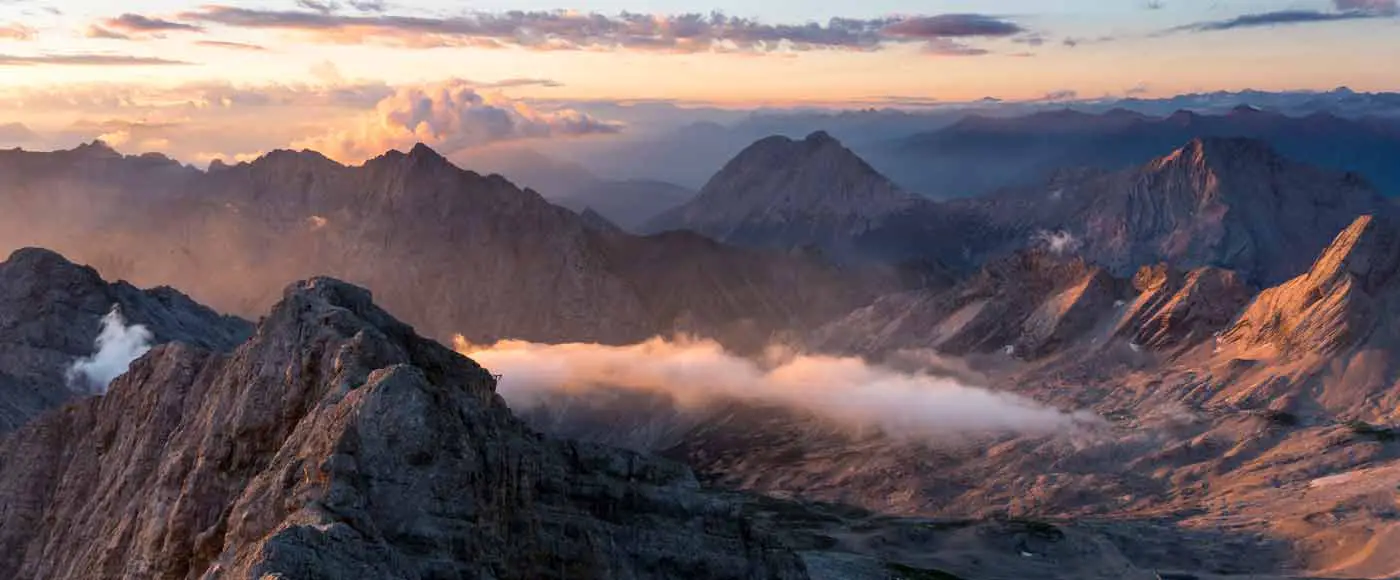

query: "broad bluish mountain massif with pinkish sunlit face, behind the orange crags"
xmin=951 ymin=139 xmax=1390 ymax=284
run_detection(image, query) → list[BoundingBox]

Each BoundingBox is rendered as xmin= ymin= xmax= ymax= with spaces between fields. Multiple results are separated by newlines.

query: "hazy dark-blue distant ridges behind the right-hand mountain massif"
xmin=869 ymin=106 xmax=1400 ymax=198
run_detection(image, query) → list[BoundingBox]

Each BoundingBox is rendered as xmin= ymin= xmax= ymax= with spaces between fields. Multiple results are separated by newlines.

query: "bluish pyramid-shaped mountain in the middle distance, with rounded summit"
xmin=645 ymin=132 xmax=921 ymax=256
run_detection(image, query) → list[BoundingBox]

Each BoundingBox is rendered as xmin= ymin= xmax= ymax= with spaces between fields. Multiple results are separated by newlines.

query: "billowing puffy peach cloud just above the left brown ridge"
xmin=295 ymin=80 xmax=622 ymax=163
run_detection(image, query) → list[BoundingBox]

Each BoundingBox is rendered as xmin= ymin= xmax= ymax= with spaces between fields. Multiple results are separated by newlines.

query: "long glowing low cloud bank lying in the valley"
xmin=455 ymin=336 xmax=1098 ymax=439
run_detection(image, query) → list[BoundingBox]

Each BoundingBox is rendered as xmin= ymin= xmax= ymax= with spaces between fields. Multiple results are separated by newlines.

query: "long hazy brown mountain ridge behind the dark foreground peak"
xmin=0 ymin=144 xmax=886 ymax=343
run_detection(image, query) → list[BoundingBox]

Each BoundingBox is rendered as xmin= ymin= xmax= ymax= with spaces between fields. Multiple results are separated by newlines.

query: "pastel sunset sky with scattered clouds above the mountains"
xmin=0 ymin=0 xmax=1400 ymax=163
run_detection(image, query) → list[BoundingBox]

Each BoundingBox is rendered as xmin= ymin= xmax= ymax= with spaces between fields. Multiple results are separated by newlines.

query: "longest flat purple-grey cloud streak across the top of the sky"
xmin=181 ymin=1 xmax=1025 ymax=52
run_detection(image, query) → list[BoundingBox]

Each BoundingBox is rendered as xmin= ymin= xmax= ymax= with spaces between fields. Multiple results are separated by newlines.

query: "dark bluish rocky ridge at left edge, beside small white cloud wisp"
xmin=0 ymin=248 xmax=252 ymax=433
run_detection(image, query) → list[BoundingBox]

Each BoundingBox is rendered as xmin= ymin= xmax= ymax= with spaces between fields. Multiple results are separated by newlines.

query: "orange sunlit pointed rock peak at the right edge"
xmin=1222 ymin=216 xmax=1400 ymax=354
